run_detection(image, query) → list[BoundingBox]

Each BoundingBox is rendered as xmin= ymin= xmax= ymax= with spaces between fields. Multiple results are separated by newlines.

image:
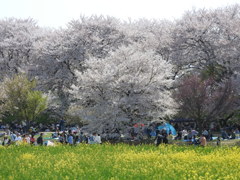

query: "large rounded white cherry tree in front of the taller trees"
xmin=68 ymin=44 xmax=176 ymax=129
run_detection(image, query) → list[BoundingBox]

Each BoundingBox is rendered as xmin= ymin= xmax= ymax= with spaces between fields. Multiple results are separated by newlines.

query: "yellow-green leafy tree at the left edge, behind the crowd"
xmin=0 ymin=75 xmax=47 ymax=122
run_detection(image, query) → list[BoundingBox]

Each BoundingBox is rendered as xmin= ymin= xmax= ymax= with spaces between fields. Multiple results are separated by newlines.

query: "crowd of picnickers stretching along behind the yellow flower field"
xmin=0 ymin=121 xmax=240 ymax=146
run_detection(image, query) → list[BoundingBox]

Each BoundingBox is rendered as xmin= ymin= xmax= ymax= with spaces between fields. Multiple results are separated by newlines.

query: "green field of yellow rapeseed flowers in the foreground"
xmin=0 ymin=144 xmax=240 ymax=180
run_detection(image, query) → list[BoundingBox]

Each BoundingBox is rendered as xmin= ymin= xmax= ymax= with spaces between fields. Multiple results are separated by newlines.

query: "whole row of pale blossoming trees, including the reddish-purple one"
xmin=0 ymin=5 xmax=240 ymax=131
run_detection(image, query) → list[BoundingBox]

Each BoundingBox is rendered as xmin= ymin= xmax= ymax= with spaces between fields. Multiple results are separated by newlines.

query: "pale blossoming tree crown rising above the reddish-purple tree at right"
xmin=170 ymin=5 xmax=240 ymax=78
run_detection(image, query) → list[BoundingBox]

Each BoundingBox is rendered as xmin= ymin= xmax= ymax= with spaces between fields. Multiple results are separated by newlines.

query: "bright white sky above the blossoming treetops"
xmin=0 ymin=0 xmax=240 ymax=28
